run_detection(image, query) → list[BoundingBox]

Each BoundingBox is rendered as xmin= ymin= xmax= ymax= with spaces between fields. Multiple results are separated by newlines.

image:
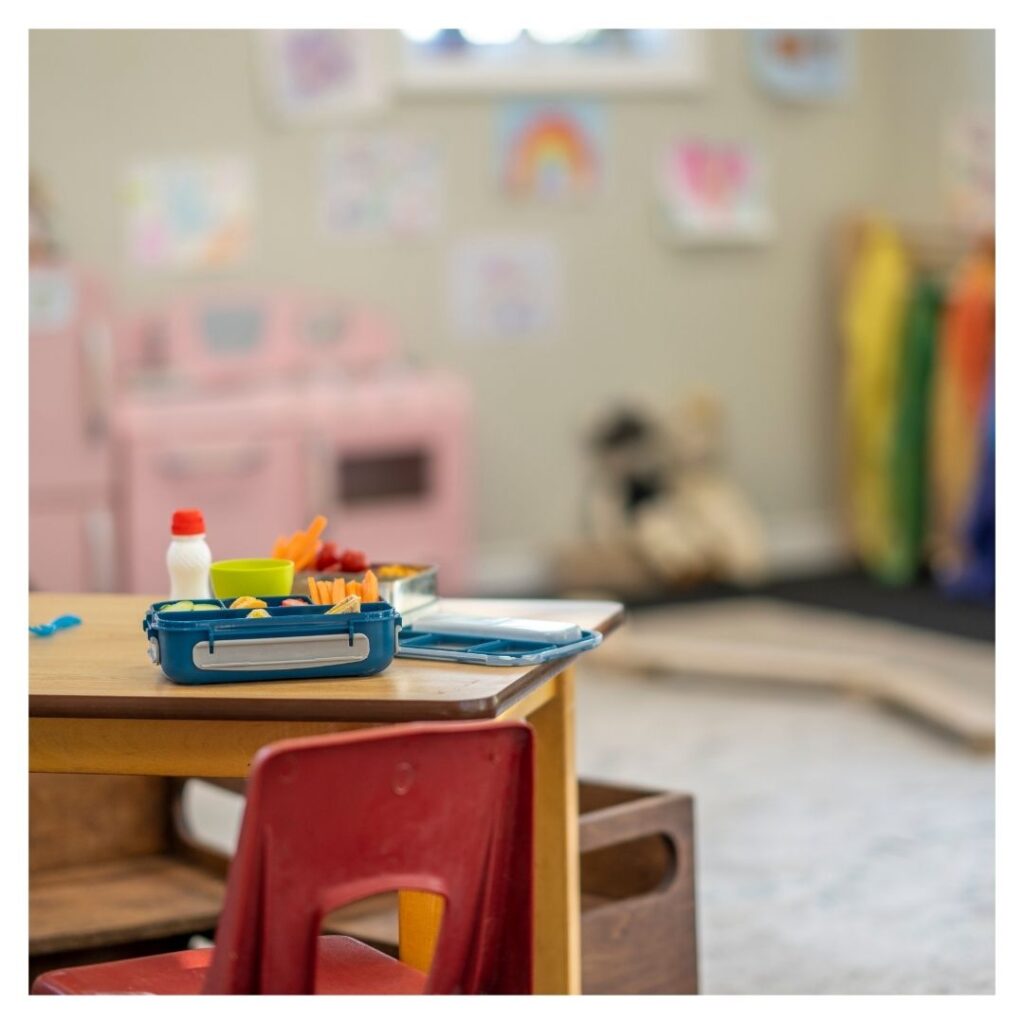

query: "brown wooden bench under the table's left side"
xmin=29 ymin=774 xmax=227 ymax=976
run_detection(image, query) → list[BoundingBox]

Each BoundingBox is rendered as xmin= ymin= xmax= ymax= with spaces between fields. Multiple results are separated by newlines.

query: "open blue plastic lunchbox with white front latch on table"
xmin=142 ymin=597 xmax=401 ymax=685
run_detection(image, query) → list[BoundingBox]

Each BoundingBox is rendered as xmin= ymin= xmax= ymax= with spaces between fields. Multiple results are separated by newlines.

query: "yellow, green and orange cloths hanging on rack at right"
xmin=837 ymin=217 xmax=994 ymax=583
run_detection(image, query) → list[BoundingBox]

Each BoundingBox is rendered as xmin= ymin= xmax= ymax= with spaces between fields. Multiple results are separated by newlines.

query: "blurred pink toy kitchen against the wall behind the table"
xmin=29 ymin=262 xmax=473 ymax=593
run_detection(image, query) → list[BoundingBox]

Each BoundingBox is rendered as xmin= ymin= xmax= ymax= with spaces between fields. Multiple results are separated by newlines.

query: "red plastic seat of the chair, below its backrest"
xmin=32 ymin=935 xmax=426 ymax=995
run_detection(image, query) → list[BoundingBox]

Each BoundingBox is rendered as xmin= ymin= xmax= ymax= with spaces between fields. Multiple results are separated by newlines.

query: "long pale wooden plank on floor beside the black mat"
xmin=590 ymin=599 xmax=995 ymax=750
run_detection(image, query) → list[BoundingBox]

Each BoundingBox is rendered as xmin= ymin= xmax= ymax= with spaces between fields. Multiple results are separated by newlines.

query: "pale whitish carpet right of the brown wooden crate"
xmin=577 ymin=658 xmax=994 ymax=993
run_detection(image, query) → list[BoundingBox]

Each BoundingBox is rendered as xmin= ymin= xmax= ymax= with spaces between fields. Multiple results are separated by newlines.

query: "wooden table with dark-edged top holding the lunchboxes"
xmin=29 ymin=594 xmax=623 ymax=993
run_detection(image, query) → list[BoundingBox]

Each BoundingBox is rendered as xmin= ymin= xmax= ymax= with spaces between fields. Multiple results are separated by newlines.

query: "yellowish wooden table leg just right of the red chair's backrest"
xmin=527 ymin=668 xmax=582 ymax=995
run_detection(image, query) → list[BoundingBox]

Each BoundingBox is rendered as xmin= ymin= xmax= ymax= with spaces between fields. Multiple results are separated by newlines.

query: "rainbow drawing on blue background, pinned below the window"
xmin=498 ymin=100 xmax=605 ymax=200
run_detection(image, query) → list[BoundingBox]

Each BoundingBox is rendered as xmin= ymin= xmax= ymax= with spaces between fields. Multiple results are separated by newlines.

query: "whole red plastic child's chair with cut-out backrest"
xmin=32 ymin=722 xmax=534 ymax=994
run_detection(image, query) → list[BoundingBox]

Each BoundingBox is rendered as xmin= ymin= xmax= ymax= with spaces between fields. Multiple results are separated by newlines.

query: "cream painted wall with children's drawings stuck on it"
xmin=30 ymin=32 xmax=986 ymax=585
